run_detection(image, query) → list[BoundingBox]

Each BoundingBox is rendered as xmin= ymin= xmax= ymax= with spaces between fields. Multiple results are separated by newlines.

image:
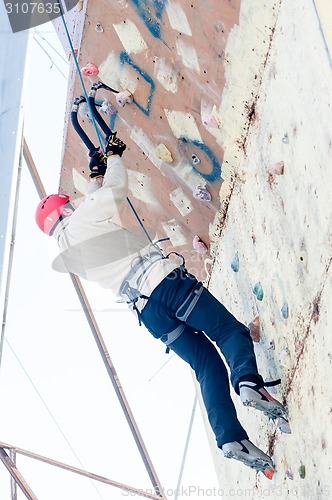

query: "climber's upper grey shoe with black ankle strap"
xmin=239 ymin=380 xmax=287 ymax=420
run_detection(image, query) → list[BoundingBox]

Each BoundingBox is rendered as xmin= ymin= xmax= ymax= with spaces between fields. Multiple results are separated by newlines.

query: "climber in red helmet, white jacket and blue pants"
xmin=36 ymin=84 xmax=285 ymax=477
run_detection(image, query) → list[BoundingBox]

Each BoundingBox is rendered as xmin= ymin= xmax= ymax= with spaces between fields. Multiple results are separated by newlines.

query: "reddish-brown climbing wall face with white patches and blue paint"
xmin=60 ymin=0 xmax=246 ymax=278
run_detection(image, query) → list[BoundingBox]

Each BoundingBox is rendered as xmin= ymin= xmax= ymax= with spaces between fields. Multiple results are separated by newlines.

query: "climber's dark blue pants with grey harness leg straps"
xmin=141 ymin=269 xmax=262 ymax=447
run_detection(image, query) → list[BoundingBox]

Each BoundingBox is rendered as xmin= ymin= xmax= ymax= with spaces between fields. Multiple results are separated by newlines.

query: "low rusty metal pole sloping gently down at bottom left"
xmin=0 ymin=442 xmax=160 ymax=500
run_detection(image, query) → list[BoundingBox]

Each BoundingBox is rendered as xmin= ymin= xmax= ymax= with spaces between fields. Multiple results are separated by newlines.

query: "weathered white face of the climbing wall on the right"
xmin=195 ymin=0 xmax=332 ymax=499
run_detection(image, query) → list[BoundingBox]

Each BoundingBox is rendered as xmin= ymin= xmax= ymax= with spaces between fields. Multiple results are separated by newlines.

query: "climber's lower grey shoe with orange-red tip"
xmin=222 ymin=439 xmax=274 ymax=475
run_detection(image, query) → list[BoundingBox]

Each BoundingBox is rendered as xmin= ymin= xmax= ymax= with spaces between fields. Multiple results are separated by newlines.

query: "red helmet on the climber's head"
xmin=36 ymin=194 xmax=69 ymax=235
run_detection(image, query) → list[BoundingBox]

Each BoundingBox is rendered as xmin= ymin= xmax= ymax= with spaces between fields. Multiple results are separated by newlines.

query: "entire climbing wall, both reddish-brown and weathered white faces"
xmin=60 ymin=0 xmax=332 ymax=499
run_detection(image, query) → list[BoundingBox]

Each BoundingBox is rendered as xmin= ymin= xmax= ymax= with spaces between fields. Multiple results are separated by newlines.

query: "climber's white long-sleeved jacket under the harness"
xmin=52 ymin=156 xmax=182 ymax=308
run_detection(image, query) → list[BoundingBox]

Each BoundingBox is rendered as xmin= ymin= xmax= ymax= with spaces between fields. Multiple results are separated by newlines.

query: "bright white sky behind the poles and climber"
xmin=0 ymin=21 xmax=218 ymax=500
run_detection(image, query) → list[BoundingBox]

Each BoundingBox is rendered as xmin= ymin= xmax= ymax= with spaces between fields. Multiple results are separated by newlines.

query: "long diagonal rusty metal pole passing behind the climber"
xmin=23 ymin=139 xmax=166 ymax=499
